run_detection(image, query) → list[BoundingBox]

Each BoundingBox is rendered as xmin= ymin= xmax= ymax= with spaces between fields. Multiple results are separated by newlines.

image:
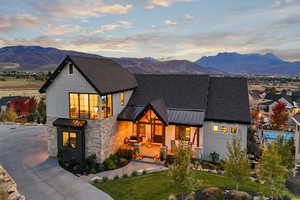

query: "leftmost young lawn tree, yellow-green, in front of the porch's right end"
xmin=169 ymin=141 xmax=195 ymax=199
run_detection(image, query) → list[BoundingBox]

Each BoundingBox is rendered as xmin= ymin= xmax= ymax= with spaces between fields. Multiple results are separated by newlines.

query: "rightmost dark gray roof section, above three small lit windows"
xmin=205 ymin=77 xmax=251 ymax=123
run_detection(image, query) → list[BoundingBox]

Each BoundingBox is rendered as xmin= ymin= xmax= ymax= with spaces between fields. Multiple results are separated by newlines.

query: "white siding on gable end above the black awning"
xmin=46 ymin=61 xmax=97 ymax=118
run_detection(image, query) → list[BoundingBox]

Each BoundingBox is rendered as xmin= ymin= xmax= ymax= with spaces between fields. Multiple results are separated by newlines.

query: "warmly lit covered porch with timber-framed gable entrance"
xmin=117 ymin=103 xmax=203 ymax=159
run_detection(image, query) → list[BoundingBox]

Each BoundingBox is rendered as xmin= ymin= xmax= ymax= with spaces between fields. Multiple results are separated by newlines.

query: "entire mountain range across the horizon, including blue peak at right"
xmin=0 ymin=46 xmax=300 ymax=76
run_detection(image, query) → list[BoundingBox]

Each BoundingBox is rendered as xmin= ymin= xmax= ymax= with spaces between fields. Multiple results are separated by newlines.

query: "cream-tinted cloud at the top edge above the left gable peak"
xmin=34 ymin=0 xmax=133 ymax=19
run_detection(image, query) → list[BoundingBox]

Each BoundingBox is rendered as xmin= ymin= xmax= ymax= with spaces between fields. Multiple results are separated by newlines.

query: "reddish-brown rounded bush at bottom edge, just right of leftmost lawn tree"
xmin=195 ymin=187 xmax=224 ymax=200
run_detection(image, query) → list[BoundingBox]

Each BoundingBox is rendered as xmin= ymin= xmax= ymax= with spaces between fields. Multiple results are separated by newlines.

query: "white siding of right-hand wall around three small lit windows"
xmin=203 ymin=122 xmax=248 ymax=160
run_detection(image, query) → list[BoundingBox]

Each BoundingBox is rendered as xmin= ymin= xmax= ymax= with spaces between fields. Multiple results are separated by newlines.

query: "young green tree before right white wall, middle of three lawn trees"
xmin=223 ymin=138 xmax=250 ymax=190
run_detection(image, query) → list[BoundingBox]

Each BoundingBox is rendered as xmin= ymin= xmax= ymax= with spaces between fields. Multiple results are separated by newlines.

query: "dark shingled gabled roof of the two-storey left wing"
xmin=39 ymin=56 xmax=137 ymax=95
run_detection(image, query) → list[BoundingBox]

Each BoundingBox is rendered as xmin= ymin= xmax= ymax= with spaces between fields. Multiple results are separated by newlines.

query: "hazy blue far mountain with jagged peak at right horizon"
xmin=195 ymin=52 xmax=300 ymax=75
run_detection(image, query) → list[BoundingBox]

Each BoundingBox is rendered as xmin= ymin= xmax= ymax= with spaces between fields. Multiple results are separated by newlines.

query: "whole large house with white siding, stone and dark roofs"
xmin=40 ymin=56 xmax=251 ymax=161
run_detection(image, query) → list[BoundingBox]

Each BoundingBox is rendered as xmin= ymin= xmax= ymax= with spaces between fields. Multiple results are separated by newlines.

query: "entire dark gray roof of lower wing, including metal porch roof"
xmin=118 ymin=74 xmax=251 ymax=126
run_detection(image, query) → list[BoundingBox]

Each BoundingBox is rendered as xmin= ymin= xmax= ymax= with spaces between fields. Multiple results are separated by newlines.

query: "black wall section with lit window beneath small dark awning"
xmin=57 ymin=128 xmax=84 ymax=163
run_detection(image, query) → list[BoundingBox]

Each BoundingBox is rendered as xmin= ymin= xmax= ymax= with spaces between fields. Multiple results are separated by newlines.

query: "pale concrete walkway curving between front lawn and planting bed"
xmin=81 ymin=161 xmax=168 ymax=182
